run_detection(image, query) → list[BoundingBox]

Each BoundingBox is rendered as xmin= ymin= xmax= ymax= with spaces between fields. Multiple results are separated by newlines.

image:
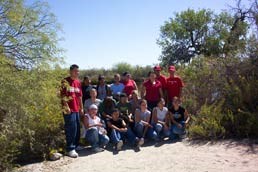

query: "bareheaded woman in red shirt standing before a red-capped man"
xmin=141 ymin=72 xmax=163 ymax=111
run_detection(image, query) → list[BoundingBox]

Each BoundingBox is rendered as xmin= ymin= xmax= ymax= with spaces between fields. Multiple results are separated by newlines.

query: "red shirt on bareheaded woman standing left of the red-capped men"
xmin=143 ymin=80 xmax=162 ymax=101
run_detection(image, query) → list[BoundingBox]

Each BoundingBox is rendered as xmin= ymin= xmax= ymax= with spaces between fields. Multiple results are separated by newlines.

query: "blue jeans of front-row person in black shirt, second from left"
xmin=111 ymin=128 xmax=136 ymax=145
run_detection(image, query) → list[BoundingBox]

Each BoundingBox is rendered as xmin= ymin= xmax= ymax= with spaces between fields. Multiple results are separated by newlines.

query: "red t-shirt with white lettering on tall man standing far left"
xmin=61 ymin=77 xmax=82 ymax=112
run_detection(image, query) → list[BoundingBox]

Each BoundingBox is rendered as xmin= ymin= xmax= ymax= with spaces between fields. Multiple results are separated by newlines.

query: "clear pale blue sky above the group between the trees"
xmin=40 ymin=0 xmax=240 ymax=69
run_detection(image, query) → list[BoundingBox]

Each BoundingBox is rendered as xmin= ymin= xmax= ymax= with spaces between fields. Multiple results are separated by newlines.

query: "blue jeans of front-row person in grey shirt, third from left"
xmin=134 ymin=122 xmax=158 ymax=140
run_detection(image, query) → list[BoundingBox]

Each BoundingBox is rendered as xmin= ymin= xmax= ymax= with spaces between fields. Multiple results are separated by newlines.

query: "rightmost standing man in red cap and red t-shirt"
xmin=166 ymin=66 xmax=184 ymax=105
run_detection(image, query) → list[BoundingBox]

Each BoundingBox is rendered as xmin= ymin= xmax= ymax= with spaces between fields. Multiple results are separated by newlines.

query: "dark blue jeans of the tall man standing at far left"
xmin=63 ymin=112 xmax=80 ymax=152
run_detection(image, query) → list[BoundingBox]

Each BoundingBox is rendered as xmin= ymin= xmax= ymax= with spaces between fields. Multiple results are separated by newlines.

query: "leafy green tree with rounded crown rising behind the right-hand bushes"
xmin=158 ymin=0 xmax=258 ymax=65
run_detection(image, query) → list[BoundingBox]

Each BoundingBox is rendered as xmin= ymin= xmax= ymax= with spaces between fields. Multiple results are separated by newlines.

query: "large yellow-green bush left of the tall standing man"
xmin=0 ymin=57 xmax=65 ymax=171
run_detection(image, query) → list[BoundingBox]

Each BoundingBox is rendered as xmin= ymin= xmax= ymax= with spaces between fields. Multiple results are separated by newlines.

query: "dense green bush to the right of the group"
xmin=179 ymin=57 xmax=258 ymax=138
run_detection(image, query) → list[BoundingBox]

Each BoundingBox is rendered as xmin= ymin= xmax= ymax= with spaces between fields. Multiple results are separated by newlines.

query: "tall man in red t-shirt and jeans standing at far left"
xmin=61 ymin=64 xmax=83 ymax=158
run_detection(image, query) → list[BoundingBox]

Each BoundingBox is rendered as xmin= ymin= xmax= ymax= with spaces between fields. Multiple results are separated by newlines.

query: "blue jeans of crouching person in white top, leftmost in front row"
xmin=85 ymin=127 xmax=109 ymax=148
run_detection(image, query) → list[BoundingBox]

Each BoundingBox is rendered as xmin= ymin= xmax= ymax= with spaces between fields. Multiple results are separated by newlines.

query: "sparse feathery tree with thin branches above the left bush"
xmin=0 ymin=0 xmax=61 ymax=69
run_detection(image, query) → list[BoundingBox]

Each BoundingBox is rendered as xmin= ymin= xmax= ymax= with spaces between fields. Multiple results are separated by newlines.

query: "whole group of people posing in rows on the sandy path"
xmin=61 ymin=65 xmax=190 ymax=158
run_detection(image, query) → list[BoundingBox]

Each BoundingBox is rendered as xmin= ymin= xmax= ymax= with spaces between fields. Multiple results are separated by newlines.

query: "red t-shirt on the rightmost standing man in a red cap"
xmin=167 ymin=76 xmax=184 ymax=101
